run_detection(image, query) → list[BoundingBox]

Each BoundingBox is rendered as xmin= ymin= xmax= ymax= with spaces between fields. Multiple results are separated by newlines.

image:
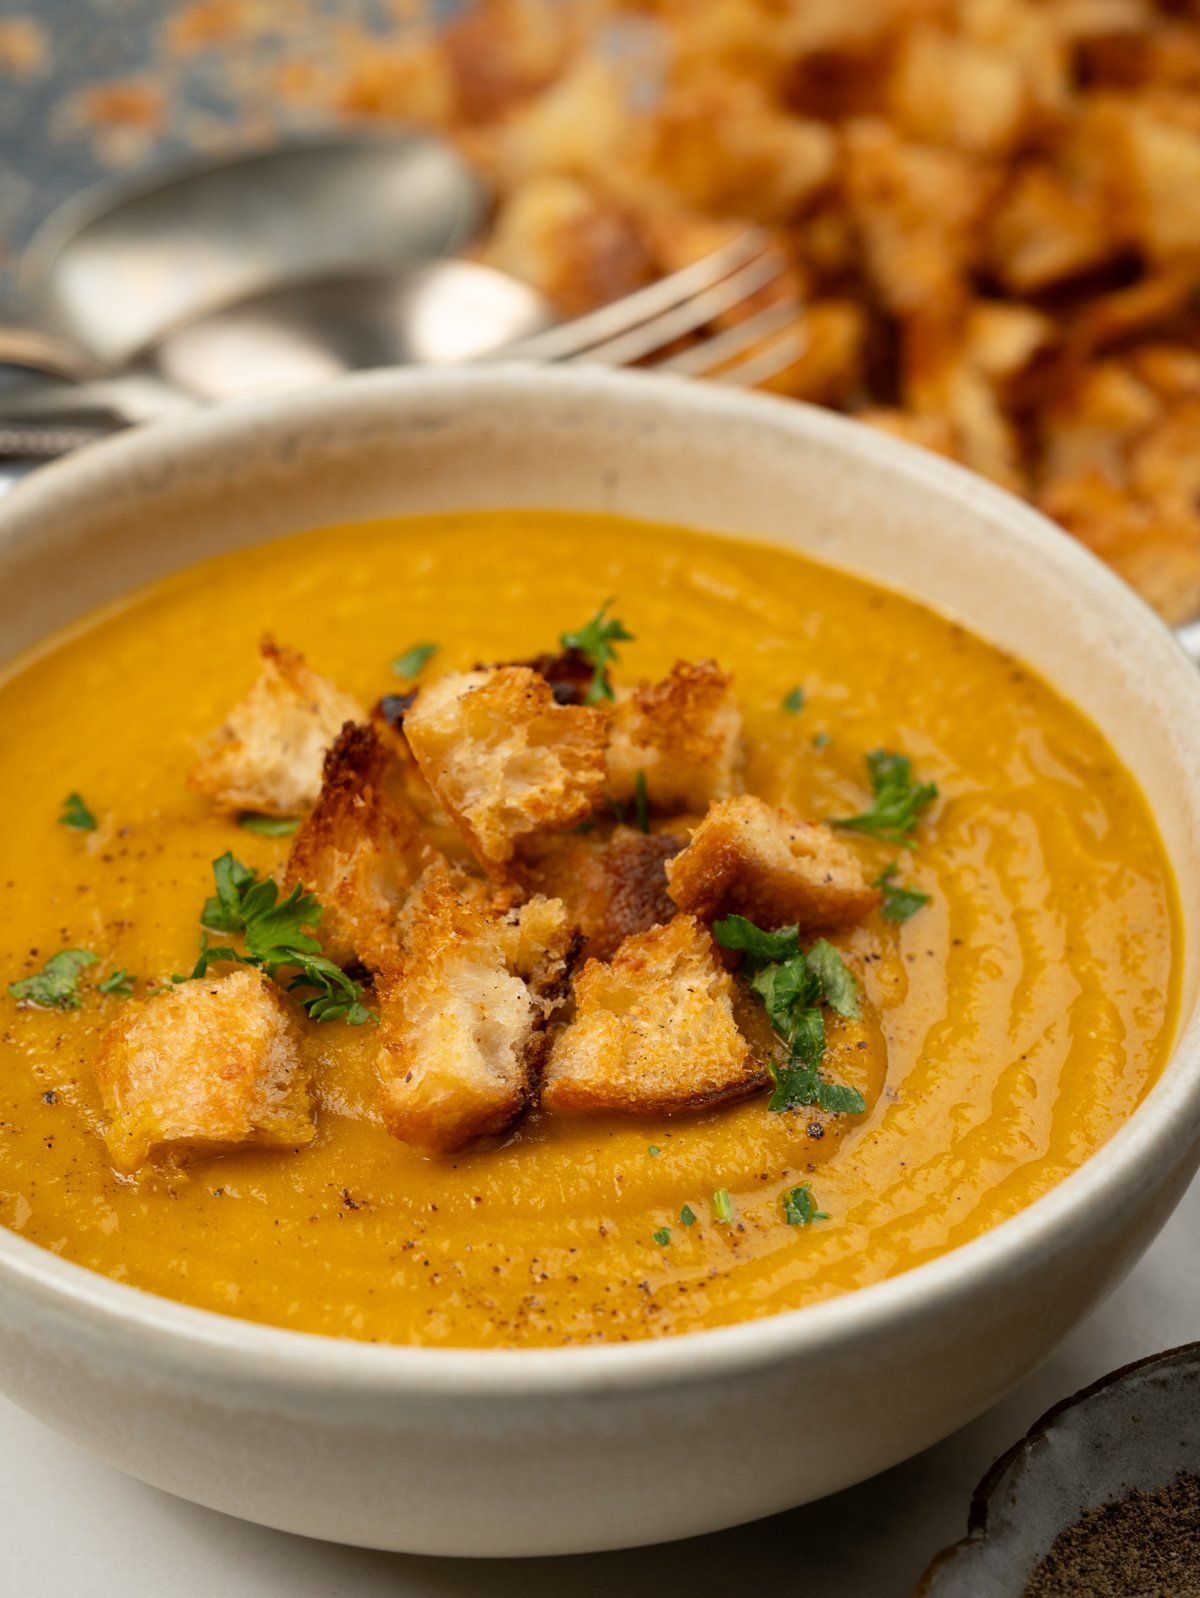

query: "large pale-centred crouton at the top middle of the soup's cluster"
xmin=404 ymin=666 xmax=606 ymax=877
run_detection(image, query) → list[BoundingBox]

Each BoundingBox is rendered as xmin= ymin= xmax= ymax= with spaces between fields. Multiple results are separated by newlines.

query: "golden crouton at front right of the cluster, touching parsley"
xmin=542 ymin=916 xmax=767 ymax=1115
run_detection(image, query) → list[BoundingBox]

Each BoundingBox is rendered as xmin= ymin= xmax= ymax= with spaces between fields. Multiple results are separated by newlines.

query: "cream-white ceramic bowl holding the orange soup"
xmin=0 ymin=369 xmax=1200 ymax=1555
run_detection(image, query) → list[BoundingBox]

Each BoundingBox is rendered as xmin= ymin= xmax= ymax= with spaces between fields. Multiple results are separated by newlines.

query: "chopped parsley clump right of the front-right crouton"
xmin=713 ymin=916 xmax=866 ymax=1115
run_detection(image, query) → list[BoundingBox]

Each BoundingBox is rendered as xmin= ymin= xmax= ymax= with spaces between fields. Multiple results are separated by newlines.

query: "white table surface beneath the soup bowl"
xmin=0 ymin=1181 xmax=1200 ymax=1598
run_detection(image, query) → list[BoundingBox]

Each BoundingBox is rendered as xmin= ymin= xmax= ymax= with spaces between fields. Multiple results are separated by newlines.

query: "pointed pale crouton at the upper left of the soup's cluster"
xmin=189 ymin=636 xmax=363 ymax=815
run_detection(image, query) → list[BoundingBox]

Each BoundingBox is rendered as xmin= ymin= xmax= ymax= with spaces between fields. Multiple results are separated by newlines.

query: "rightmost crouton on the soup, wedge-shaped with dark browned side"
xmin=666 ymin=794 xmax=880 ymax=932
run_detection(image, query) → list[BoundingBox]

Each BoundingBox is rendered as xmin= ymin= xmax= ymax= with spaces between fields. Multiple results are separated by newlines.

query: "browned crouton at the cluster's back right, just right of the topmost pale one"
xmin=607 ymin=660 xmax=743 ymax=815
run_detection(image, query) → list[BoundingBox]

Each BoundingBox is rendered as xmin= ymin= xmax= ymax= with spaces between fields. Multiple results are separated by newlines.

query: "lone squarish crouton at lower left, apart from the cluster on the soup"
xmin=93 ymin=968 xmax=315 ymax=1171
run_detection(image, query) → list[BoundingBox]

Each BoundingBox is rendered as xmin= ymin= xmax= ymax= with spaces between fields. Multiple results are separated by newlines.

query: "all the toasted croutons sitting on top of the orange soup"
xmin=96 ymin=639 xmax=880 ymax=1170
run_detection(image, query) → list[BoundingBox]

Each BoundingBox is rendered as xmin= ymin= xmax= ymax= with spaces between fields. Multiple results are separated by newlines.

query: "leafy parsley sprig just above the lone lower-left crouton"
xmin=174 ymin=853 xmax=374 ymax=1026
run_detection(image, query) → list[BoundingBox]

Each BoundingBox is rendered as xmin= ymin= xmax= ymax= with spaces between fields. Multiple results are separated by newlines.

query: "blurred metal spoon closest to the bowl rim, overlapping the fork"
xmin=0 ymin=260 xmax=556 ymax=459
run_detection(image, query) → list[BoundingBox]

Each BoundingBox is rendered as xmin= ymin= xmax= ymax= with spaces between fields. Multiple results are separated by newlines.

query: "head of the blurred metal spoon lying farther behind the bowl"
xmin=11 ymin=131 xmax=486 ymax=367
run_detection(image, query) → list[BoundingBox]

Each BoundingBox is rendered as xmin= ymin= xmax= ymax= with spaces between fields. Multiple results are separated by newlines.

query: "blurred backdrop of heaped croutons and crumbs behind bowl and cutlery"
xmin=0 ymin=0 xmax=1200 ymax=622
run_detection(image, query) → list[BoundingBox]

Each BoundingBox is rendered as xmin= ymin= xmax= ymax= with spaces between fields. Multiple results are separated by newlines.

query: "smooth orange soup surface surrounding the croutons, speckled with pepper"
xmin=0 ymin=510 xmax=1179 ymax=1347
